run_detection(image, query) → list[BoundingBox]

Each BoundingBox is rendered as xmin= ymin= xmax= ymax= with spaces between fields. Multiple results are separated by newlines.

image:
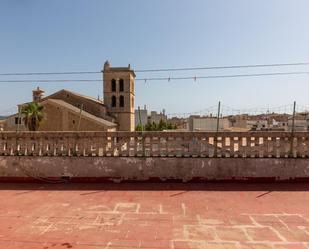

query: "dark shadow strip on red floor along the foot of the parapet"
xmin=0 ymin=182 xmax=309 ymax=192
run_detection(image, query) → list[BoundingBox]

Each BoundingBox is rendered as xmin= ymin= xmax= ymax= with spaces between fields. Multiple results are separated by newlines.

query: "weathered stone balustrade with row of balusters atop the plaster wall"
xmin=0 ymin=132 xmax=309 ymax=158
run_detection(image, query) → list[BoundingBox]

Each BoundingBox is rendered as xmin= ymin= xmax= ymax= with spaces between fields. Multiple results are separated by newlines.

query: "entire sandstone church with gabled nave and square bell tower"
xmin=4 ymin=61 xmax=135 ymax=131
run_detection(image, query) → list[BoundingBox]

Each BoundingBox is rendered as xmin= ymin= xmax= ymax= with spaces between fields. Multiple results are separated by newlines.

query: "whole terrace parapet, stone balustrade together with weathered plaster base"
xmin=0 ymin=132 xmax=309 ymax=181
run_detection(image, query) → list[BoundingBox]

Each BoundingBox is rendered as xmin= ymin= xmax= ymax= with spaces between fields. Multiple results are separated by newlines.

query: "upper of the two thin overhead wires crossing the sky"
xmin=0 ymin=62 xmax=309 ymax=76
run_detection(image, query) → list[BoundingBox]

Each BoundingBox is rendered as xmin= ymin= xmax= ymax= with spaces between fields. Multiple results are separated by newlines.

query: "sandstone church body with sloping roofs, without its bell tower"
xmin=4 ymin=90 xmax=117 ymax=131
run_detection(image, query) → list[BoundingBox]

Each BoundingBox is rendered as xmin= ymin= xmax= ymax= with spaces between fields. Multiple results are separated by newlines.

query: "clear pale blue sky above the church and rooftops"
xmin=0 ymin=0 xmax=309 ymax=114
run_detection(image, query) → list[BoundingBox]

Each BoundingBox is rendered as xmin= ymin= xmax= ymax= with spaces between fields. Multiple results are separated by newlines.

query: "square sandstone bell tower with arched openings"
xmin=103 ymin=61 xmax=135 ymax=131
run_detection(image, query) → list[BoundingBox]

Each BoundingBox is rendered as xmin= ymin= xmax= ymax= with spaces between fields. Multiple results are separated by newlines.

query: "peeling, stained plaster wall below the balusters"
xmin=0 ymin=156 xmax=309 ymax=181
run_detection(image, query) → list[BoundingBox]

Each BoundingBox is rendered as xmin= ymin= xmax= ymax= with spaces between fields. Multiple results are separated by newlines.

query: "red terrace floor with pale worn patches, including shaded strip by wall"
xmin=0 ymin=183 xmax=309 ymax=249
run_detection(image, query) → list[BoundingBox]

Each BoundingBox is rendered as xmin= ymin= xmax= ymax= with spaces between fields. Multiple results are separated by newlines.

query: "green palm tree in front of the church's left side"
xmin=21 ymin=102 xmax=44 ymax=131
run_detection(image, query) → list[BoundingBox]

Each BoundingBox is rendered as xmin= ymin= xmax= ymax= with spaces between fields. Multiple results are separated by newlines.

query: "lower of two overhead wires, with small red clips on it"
xmin=0 ymin=71 xmax=309 ymax=83
